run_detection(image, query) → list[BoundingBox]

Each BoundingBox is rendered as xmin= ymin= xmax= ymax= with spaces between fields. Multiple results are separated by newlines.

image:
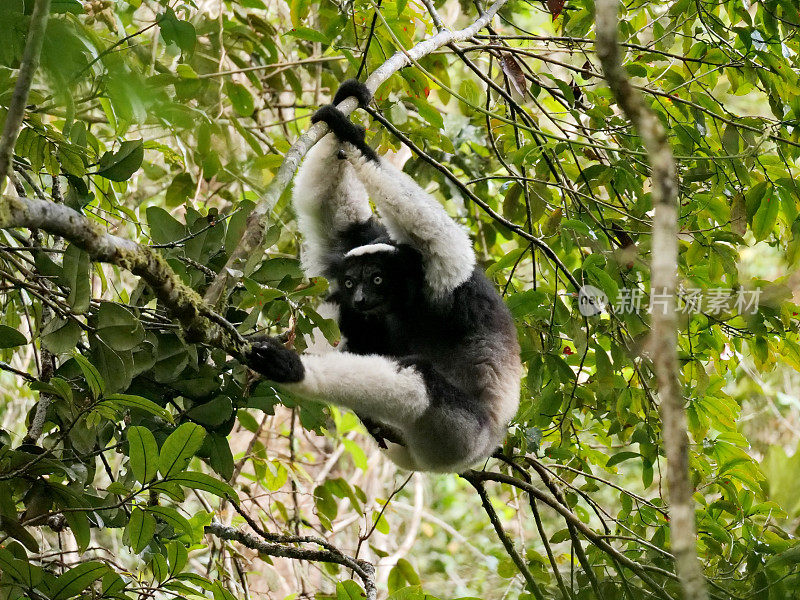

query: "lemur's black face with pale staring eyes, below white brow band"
xmin=339 ymin=254 xmax=393 ymax=316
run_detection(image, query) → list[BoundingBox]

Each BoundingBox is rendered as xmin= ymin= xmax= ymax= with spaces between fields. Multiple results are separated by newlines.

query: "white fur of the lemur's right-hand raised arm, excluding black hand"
xmin=349 ymin=153 xmax=475 ymax=297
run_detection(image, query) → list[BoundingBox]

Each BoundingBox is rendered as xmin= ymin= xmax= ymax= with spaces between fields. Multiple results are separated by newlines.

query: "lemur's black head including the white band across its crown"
xmin=336 ymin=243 xmax=417 ymax=316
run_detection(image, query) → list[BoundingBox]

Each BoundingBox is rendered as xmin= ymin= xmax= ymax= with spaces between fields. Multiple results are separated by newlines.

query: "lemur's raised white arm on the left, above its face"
xmin=292 ymin=83 xmax=376 ymax=276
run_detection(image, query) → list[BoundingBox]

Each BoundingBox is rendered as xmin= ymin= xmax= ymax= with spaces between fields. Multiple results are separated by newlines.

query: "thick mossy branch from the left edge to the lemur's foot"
xmin=0 ymin=196 xmax=248 ymax=359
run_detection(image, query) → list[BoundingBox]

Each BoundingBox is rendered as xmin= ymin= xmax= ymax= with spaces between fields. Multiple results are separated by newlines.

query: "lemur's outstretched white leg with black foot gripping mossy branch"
xmin=248 ymin=338 xmax=430 ymax=432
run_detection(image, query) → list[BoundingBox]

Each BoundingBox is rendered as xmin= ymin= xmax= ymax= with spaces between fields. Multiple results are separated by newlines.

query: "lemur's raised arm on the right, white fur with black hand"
xmin=314 ymin=80 xmax=475 ymax=297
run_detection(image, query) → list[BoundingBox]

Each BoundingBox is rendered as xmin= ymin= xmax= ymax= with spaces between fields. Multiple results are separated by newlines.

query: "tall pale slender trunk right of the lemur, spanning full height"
xmin=595 ymin=0 xmax=708 ymax=600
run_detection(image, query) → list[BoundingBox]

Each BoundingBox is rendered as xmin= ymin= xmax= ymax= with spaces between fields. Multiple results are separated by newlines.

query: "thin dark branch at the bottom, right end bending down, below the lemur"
xmin=205 ymin=523 xmax=377 ymax=600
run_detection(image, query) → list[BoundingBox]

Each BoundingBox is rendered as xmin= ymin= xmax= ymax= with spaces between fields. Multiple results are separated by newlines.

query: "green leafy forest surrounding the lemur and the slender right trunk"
xmin=0 ymin=0 xmax=800 ymax=600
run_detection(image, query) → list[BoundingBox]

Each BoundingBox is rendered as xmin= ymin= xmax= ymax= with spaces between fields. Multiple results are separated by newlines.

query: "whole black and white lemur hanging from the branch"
xmin=249 ymin=80 xmax=522 ymax=472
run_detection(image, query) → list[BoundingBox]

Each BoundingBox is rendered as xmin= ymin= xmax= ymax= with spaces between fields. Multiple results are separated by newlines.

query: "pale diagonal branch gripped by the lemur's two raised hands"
xmin=205 ymin=0 xmax=506 ymax=306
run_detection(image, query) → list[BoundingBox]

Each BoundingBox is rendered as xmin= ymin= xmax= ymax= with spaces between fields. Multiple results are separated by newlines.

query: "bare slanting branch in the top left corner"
xmin=0 ymin=0 xmax=50 ymax=192
